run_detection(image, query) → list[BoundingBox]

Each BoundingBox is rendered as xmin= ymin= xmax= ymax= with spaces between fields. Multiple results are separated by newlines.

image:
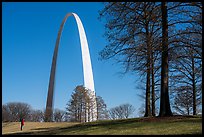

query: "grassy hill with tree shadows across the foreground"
xmin=2 ymin=116 xmax=202 ymax=135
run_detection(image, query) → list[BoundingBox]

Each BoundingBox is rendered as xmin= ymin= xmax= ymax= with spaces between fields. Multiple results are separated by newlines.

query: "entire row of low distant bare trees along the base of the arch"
xmin=2 ymin=85 xmax=135 ymax=122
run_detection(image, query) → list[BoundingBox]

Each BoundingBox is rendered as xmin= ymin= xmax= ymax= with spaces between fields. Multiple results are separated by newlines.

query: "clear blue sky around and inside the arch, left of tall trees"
xmin=2 ymin=2 xmax=144 ymax=115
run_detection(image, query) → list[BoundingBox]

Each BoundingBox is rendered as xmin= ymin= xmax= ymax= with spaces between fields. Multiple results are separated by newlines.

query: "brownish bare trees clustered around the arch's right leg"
xmin=66 ymin=85 xmax=135 ymax=122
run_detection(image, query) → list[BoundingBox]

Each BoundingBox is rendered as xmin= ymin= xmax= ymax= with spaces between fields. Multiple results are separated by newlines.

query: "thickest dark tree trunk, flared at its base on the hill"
xmin=159 ymin=2 xmax=172 ymax=117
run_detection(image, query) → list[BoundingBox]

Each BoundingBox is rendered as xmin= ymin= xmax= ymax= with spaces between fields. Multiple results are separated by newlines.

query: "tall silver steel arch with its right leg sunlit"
xmin=45 ymin=13 xmax=97 ymax=122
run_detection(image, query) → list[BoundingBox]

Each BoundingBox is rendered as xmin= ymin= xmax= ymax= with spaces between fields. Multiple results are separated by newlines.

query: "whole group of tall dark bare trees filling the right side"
xmin=100 ymin=2 xmax=202 ymax=117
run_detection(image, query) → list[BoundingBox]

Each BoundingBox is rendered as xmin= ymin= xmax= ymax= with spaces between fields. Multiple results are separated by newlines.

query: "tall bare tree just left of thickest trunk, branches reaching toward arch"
xmin=100 ymin=2 xmax=161 ymax=116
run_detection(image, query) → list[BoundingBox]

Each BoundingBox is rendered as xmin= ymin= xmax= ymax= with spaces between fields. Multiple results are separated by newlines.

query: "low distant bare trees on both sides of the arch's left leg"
xmin=2 ymin=102 xmax=69 ymax=122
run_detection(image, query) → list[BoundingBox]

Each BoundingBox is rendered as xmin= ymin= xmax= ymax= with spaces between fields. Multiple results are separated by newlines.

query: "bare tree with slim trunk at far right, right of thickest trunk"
xmin=167 ymin=2 xmax=202 ymax=115
